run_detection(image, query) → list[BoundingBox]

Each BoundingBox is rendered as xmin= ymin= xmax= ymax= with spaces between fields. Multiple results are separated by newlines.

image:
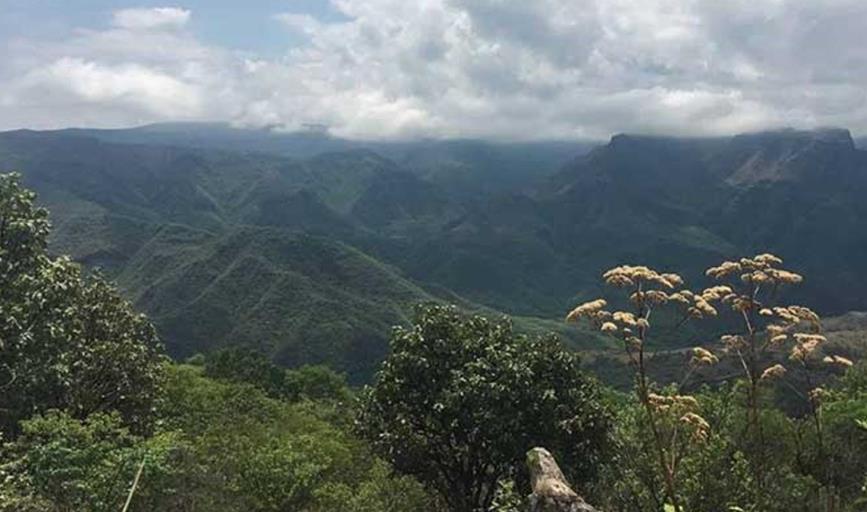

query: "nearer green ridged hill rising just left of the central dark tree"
xmin=116 ymin=226 xmax=433 ymax=376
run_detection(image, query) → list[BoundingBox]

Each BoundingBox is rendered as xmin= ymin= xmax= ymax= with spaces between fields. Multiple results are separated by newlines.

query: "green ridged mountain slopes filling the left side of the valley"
xmin=0 ymin=127 xmax=593 ymax=379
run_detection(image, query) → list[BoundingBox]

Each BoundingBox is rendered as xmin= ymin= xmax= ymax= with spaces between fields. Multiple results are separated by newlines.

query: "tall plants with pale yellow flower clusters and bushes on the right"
xmin=567 ymin=254 xmax=867 ymax=512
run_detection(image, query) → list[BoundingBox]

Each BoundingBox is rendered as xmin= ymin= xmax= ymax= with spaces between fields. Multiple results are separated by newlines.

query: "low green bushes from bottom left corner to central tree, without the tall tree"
xmin=0 ymin=366 xmax=428 ymax=512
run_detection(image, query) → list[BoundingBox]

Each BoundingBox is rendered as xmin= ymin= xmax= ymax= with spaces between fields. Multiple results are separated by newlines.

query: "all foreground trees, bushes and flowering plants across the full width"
xmin=0 ymin=171 xmax=867 ymax=512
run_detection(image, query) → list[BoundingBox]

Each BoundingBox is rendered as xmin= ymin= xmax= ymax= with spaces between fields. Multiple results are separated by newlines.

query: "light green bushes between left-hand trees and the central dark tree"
xmin=157 ymin=366 xmax=430 ymax=512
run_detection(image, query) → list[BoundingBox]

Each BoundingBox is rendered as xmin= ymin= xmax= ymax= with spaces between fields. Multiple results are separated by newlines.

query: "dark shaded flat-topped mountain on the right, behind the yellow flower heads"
xmin=407 ymin=131 xmax=867 ymax=315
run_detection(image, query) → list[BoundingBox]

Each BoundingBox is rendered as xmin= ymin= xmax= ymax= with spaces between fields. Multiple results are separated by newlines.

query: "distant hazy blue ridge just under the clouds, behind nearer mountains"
xmin=55 ymin=123 xmax=598 ymax=201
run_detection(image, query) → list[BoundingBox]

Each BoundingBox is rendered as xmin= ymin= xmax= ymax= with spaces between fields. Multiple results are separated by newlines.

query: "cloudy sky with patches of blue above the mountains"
xmin=0 ymin=0 xmax=867 ymax=140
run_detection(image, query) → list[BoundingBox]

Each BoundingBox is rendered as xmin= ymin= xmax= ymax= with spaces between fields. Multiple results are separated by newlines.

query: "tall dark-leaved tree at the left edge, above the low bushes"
xmin=0 ymin=174 xmax=164 ymax=438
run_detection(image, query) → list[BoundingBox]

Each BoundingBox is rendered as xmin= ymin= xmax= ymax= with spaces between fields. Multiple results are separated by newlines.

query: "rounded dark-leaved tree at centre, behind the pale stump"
xmin=357 ymin=304 xmax=609 ymax=512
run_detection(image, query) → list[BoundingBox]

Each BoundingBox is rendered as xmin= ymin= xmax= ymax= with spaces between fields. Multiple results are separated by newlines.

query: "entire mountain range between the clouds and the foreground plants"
xmin=0 ymin=124 xmax=867 ymax=378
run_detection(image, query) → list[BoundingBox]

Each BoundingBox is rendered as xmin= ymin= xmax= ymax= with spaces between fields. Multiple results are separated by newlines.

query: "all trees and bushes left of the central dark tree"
xmin=0 ymin=175 xmax=430 ymax=512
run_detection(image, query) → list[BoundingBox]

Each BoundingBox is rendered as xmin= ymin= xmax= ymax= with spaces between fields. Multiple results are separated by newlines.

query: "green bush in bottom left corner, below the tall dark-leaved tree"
xmin=0 ymin=411 xmax=195 ymax=512
